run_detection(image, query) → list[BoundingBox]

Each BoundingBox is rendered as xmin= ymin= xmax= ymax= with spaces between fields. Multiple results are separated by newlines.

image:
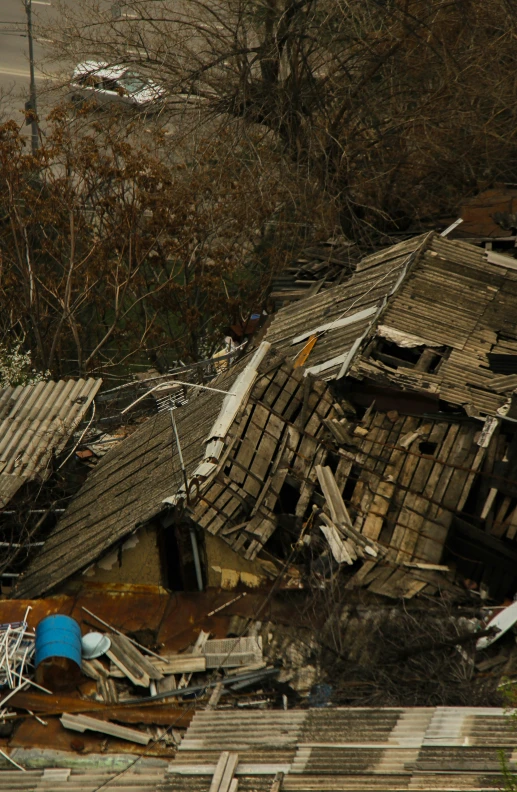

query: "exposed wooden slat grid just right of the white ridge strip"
xmin=189 ymin=352 xmax=335 ymax=560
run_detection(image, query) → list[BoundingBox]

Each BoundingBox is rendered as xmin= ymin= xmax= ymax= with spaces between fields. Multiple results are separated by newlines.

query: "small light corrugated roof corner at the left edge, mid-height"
xmin=0 ymin=379 xmax=102 ymax=507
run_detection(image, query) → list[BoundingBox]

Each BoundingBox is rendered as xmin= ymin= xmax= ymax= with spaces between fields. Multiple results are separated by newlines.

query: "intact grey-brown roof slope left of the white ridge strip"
xmin=14 ymin=358 xmax=252 ymax=598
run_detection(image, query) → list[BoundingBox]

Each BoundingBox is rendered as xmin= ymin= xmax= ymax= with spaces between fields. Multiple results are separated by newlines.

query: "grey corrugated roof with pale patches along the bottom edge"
xmin=164 ymin=707 xmax=517 ymax=792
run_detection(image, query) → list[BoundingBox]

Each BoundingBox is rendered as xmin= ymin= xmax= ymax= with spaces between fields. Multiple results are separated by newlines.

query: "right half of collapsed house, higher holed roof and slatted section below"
xmin=266 ymin=233 xmax=517 ymax=596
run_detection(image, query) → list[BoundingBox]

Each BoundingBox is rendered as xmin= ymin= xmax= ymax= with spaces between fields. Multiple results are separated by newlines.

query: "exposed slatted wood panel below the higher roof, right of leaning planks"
xmin=326 ymin=411 xmax=485 ymax=564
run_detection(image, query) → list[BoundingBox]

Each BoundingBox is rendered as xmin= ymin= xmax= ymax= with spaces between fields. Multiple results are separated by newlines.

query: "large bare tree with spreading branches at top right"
xmin=40 ymin=0 xmax=517 ymax=239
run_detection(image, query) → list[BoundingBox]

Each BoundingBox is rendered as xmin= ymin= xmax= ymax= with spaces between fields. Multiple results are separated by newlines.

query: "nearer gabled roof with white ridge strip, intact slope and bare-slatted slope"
xmin=15 ymin=343 xmax=354 ymax=597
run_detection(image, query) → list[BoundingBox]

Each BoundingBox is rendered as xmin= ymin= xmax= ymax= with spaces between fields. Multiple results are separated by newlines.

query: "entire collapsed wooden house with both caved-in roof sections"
xmin=11 ymin=233 xmax=517 ymax=597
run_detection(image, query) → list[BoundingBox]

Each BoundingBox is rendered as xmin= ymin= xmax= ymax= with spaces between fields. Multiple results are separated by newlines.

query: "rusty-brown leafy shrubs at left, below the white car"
xmin=0 ymin=108 xmax=326 ymax=376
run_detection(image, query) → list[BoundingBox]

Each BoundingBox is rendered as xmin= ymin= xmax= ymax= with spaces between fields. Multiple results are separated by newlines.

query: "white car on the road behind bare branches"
xmin=70 ymin=61 xmax=166 ymax=111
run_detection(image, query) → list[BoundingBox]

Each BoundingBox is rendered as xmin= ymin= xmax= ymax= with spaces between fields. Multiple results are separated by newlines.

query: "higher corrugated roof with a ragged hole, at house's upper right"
xmin=266 ymin=233 xmax=517 ymax=416
